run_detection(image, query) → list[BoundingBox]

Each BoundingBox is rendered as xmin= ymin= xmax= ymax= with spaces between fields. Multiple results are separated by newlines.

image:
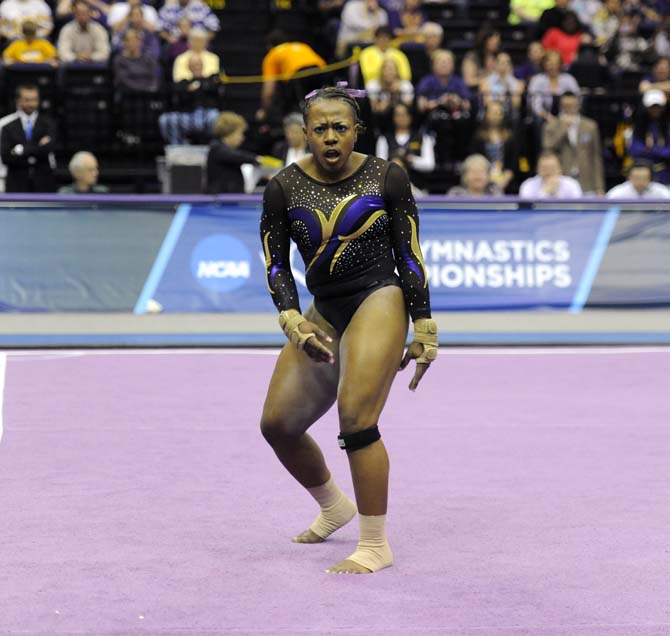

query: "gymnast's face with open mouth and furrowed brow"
xmin=305 ymin=99 xmax=356 ymax=176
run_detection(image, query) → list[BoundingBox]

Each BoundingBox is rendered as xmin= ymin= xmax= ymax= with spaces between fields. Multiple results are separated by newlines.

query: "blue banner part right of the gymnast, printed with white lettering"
xmin=421 ymin=209 xmax=618 ymax=311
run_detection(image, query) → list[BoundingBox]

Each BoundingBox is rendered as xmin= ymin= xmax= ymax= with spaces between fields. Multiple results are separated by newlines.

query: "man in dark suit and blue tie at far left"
xmin=0 ymin=84 xmax=56 ymax=192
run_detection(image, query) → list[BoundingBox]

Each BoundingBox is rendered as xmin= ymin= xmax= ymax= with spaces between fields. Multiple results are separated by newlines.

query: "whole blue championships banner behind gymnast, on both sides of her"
xmin=144 ymin=204 xmax=618 ymax=313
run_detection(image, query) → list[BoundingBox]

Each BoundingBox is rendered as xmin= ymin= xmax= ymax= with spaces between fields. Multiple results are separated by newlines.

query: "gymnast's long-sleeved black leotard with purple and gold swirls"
xmin=261 ymin=157 xmax=430 ymax=333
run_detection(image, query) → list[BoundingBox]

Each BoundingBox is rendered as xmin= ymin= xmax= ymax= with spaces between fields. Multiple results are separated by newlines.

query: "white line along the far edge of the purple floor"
xmin=0 ymin=346 xmax=670 ymax=362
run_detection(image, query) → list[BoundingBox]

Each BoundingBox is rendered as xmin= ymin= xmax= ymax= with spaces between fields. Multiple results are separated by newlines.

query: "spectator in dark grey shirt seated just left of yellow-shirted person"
xmin=113 ymin=29 xmax=159 ymax=92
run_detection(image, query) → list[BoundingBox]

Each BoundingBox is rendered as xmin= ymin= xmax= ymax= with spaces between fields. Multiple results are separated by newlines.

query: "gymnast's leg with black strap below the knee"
xmin=327 ymin=286 xmax=408 ymax=574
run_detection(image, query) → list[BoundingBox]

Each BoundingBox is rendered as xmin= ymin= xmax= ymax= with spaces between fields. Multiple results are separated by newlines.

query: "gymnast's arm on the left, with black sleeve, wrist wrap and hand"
xmin=260 ymin=179 xmax=333 ymax=364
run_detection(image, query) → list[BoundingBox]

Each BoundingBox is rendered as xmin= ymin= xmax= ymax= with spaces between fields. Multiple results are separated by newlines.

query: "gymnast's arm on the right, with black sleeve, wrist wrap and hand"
xmin=384 ymin=164 xmax=438 ymax=391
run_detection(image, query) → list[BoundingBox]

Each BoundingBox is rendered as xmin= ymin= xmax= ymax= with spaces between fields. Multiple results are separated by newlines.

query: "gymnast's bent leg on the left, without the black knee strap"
xmin=261 ymin=307 xmax=356 ymax=543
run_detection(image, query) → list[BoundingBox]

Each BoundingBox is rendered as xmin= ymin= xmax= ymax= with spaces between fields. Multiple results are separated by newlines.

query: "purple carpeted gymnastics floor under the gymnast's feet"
xmin=0 ymin=349 xmax=670 ymax=636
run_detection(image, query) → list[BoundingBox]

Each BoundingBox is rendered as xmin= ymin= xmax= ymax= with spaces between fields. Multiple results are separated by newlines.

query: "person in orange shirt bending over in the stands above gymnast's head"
xmin=256 ymin=30 xmax=326 ymax=121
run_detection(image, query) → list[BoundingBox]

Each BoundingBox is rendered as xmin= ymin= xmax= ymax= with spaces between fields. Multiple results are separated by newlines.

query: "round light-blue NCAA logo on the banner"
xmin=191 ymin=234 xmax=251 ymax=292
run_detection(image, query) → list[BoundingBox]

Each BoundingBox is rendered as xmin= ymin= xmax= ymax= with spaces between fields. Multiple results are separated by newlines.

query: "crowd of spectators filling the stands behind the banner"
xmin=0 ymin=0 xmax=670 ymax=198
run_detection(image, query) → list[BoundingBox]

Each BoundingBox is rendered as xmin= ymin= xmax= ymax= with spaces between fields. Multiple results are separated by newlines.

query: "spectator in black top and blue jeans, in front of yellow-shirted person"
xmin=158 ymin=55 xmax=221 ymax=144
